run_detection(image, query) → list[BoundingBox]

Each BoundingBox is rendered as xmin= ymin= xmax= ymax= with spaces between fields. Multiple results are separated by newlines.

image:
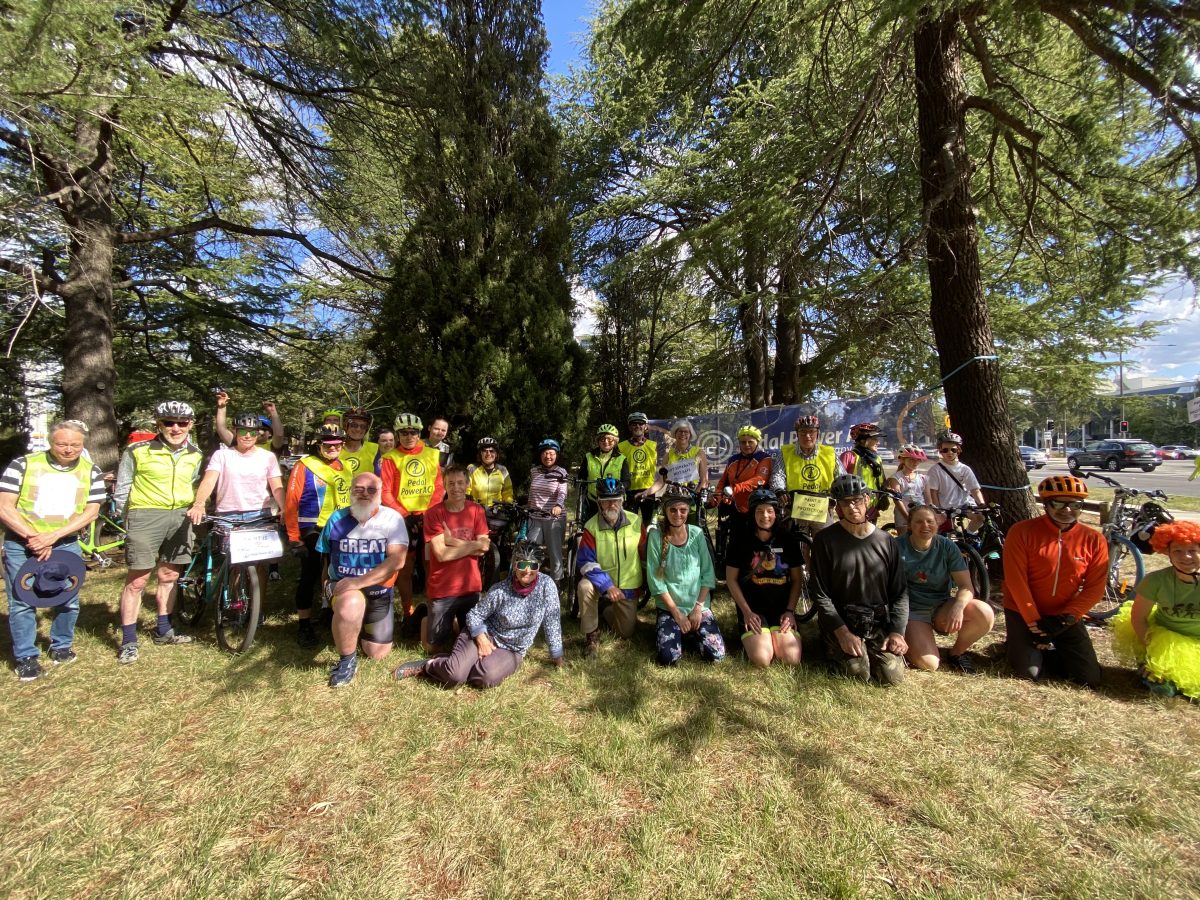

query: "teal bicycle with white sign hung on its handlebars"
xmin=175 ymin=516 xmax=283 ymax=653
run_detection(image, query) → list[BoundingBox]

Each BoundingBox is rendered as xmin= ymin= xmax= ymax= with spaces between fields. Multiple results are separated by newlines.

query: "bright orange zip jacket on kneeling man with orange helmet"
xmin=1004 ymin=516 xmax=1109 ymax=625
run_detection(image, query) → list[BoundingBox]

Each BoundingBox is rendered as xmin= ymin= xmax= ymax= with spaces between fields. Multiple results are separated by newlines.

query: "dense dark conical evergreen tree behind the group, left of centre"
xmin=376 ymin=0 xmax=583 ymax=461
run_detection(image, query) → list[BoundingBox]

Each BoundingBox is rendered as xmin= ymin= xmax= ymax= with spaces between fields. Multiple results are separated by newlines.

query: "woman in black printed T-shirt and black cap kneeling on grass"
xmin=725 ymin=487 xmax=804 ymax=668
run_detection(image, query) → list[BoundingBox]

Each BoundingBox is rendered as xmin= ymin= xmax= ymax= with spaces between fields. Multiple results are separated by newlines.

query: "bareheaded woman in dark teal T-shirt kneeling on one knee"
xmin=896 ymin=505 xmax=996 ymax=674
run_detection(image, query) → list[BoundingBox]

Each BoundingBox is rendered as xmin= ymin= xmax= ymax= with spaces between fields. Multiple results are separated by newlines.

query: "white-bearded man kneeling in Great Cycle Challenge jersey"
xmin=317 ymin=472 xmax=408 ymax=688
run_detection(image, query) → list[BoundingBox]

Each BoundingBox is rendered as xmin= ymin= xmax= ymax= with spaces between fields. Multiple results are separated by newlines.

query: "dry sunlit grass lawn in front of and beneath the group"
xmin=0 ymin=556 xmax=1200 ymax=898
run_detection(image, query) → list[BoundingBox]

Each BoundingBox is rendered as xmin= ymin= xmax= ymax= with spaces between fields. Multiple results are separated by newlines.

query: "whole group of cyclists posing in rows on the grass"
xmin=0 ymin=403 xmax=1200 ymax=696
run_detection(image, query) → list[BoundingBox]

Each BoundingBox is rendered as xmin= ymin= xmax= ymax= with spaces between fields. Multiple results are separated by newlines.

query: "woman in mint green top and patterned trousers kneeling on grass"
xmin=646 ymin=493 xmax=725 ymax=666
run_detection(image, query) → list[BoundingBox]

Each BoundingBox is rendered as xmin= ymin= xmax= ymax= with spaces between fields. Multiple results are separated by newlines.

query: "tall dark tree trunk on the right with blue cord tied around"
xmin=913 ymin=11 xmax=1036 ymax=527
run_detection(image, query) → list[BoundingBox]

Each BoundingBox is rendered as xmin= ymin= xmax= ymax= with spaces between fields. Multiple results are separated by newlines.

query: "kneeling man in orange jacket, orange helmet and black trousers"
xmin=1004 ymin=475 xmax=1109 ymax=688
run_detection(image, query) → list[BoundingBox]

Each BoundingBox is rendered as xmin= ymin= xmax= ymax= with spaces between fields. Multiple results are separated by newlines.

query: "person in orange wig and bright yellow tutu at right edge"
xmin=1112 ymin=522 xmax=1200 ymax=700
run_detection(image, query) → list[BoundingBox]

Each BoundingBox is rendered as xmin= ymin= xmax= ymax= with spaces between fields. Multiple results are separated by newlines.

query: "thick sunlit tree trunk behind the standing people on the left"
xmin=60 ymin=121 xmax=120 ymax=480
